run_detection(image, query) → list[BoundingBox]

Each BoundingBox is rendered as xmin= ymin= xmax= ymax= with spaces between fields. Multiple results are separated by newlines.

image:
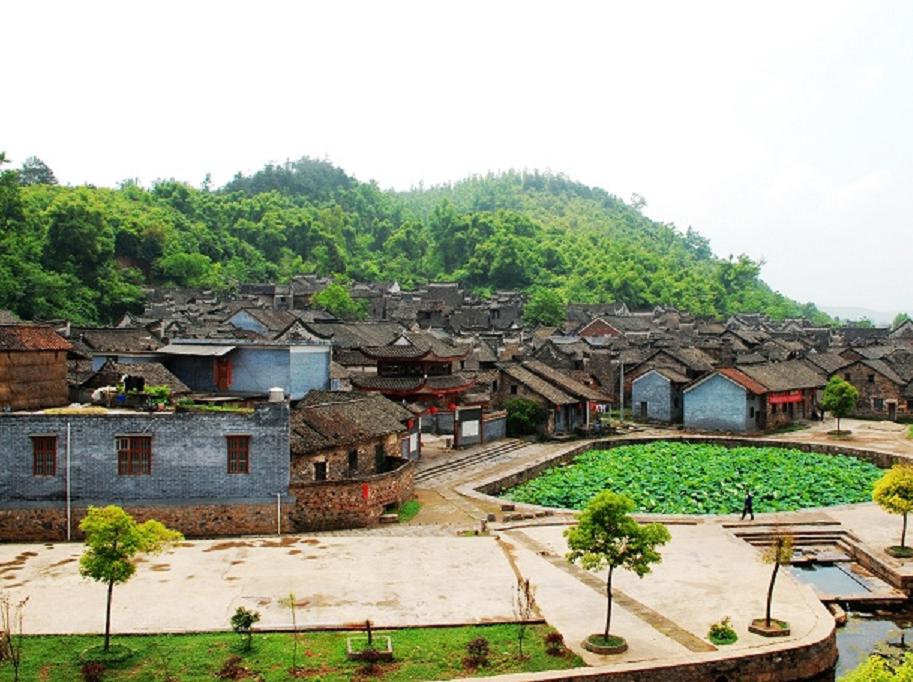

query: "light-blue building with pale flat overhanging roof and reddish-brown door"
xmin=160 ymin=339 xmax=330 ymax=400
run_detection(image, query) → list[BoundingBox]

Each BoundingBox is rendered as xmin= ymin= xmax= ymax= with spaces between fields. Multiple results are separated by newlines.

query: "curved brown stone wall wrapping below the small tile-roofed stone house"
xmin=289 ymin=460 xmax=415 ymax=531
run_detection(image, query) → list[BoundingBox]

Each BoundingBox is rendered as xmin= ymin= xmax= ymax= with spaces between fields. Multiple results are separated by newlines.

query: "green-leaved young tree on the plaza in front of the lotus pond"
xmin=564 ymin=490 xmax=671 ymax=643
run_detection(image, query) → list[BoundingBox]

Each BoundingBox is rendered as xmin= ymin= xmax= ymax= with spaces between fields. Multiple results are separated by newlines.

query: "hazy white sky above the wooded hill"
xmin=0 ymin=0 xmax=913 ymax=313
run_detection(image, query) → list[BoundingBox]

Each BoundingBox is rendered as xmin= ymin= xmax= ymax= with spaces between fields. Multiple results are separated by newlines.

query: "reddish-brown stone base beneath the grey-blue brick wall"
xmin=0 ymin=497 xmax=293 ymax=542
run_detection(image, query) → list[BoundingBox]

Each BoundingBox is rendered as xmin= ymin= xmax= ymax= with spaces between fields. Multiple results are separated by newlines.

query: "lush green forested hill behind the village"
xmin=0 ymin=157 xmax=821 ymax=323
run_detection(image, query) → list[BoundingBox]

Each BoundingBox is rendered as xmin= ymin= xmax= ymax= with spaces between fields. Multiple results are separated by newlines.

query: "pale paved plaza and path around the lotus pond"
xmin=0 ymin=424 xmax=913 ymax=668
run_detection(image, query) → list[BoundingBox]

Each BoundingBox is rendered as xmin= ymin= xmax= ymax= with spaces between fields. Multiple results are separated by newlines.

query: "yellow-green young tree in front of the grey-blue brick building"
xmin=79 ymin=505 xmax=184 ymax=651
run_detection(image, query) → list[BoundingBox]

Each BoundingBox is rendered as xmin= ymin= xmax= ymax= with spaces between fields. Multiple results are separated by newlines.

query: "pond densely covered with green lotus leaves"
xmin=501 ymin=441 xmax=883 ymax=514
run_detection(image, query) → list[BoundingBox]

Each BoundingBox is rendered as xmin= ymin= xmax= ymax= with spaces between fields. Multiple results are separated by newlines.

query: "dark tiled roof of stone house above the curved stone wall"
xmin=290 ymin=391 xmax=413 ymax=455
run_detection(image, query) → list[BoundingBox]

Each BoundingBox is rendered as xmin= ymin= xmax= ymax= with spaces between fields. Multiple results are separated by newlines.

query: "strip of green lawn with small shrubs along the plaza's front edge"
xmin=0 ymin=625 xmax=583 ymax=682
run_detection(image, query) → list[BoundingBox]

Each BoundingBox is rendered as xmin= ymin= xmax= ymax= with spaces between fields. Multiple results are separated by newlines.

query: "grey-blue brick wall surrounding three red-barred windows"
xmin=0 ymin=403 xmax=289 ymax=507
